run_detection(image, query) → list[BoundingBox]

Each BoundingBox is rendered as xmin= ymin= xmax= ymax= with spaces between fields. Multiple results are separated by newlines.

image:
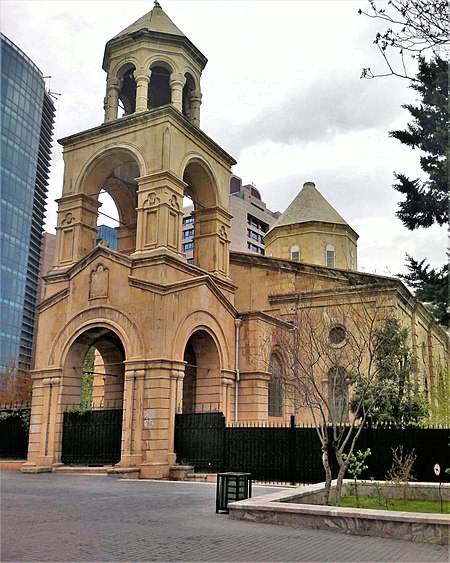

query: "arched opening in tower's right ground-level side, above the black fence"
xmin=183 ymin=330 xmax=222 ymax=414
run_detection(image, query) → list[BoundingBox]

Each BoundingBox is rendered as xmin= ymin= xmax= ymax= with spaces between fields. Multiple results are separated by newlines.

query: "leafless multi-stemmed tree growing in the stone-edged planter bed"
xmin=272 ymin=288 xmax=400 ymax=505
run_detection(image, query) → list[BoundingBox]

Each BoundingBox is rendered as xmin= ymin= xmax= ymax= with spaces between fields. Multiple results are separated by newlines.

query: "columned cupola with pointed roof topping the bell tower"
xmin=103 ymin=1 xmax=207 ymax=127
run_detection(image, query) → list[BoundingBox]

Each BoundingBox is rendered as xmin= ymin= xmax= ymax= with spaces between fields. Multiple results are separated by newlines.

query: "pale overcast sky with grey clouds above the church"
xmin=0 ymin=0 xmax=446 ymax=275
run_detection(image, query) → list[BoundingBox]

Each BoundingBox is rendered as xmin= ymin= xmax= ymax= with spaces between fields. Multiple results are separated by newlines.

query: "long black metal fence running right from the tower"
xmin=175 ymin=413 xmax=450 ymax=483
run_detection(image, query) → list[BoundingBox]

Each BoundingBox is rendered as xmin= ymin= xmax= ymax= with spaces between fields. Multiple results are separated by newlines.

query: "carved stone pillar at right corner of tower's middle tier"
xmin=193 ymin=207 xmax=231 ymax=277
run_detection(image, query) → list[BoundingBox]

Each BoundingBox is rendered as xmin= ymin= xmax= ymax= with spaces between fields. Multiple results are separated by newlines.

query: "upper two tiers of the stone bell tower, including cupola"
xmin=52 ymin=2 xmax=235 ymax=278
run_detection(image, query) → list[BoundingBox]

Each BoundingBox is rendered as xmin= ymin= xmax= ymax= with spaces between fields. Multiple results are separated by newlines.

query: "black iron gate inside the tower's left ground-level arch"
xmin=61 ymin=409 xmax=123 ymax=466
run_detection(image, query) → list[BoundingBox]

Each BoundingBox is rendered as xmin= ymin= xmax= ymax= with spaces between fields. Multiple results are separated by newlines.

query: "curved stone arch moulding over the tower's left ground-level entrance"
xmin=48 ymin=307 xmax=144 ymax=367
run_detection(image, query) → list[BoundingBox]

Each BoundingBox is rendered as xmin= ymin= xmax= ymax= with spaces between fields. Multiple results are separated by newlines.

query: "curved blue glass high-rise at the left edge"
xmin=0 ymin=35 xmax=55 ymax=370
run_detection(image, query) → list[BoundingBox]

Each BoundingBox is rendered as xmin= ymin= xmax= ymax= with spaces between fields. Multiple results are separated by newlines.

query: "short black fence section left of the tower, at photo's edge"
xmin=0 ymin=408 xmax=30 ymax=460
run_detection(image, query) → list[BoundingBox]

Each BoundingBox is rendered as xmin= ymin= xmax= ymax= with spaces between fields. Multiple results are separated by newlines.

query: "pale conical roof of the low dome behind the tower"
xmin=271 ymin=182 xmax=348 ymax=230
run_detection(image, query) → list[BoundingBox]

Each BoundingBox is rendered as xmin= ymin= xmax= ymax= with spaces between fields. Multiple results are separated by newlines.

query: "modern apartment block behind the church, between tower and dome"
xmin=182 ymin=175 xmax=281 ymax=264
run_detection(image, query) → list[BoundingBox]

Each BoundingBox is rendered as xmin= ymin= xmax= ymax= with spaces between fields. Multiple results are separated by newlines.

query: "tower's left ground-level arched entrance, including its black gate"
xmin=61 ymin=327 xmax=125 ymax=466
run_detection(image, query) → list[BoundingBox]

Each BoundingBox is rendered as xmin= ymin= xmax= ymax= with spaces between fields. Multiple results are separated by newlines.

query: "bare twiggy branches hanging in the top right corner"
xmin=358 ymin=0 xmax=450 ymax=80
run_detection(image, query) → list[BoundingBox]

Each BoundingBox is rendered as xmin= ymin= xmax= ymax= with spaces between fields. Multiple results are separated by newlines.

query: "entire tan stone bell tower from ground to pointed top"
xmin=25 ymin=2 xmax=236 ymax=478
